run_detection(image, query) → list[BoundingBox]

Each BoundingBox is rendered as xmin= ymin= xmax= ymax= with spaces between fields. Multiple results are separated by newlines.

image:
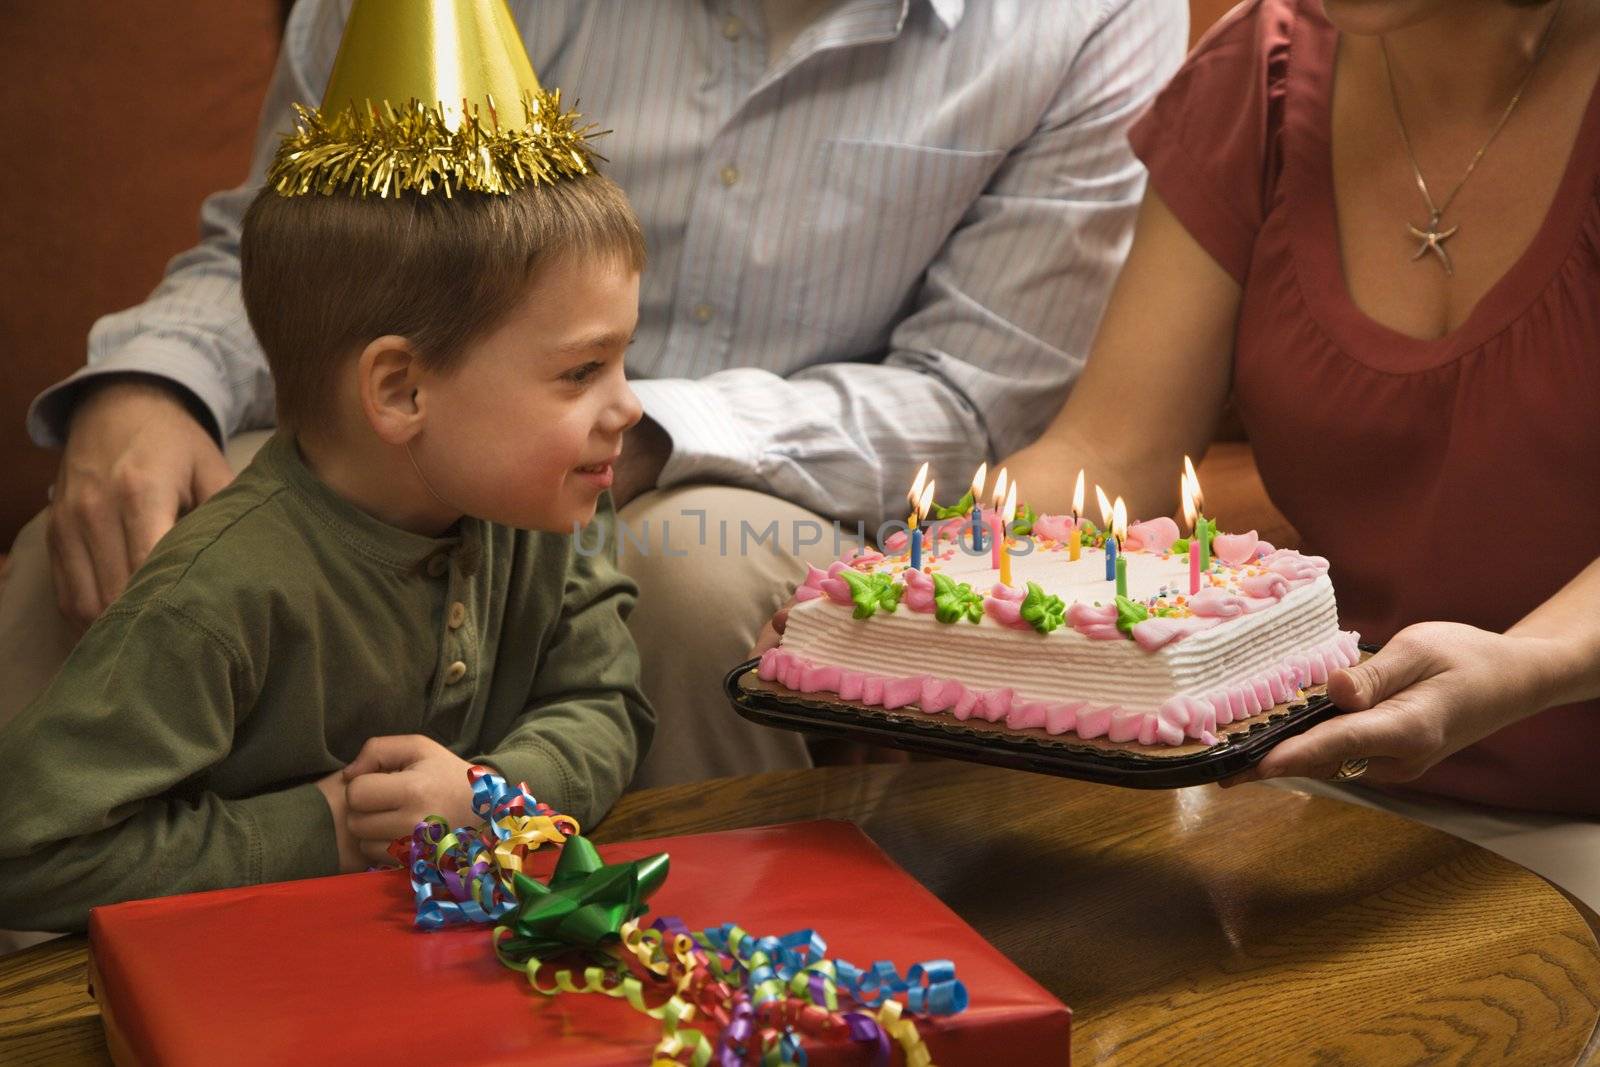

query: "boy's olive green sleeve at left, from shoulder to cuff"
xmin=0 ymin=601 xmax=339 ymax=929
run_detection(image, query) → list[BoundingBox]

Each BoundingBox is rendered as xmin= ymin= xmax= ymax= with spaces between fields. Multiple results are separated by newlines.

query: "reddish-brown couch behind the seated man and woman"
xmin=0 ymin=0 xmax=1296 ymax=560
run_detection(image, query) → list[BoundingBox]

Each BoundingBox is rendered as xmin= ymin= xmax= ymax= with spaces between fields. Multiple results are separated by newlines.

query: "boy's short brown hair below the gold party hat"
xmin=240 ymin=174 xmax=645 ymax=429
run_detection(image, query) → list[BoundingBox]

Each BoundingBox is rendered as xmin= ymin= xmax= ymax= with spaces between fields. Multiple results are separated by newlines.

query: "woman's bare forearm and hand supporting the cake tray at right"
xmin=1227 ymin=560 xmax=1600 ymax=785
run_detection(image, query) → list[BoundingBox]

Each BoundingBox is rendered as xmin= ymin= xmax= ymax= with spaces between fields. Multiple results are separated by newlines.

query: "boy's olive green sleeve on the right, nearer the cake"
xmin=472 ymin=501 xmax=656 ymax=827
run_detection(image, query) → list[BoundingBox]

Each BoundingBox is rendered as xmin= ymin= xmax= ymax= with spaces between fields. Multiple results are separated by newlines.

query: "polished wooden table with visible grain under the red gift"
xmin=9 ymin=761 xmax=1600 ymax=1067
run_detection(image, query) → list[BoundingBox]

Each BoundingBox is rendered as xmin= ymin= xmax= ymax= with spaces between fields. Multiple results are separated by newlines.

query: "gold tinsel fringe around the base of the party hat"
xmin=267 ymin=90 xmax=610 ymax=197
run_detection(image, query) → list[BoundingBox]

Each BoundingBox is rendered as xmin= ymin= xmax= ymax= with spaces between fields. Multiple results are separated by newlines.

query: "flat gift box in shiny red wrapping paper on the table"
xmin=90 ymin=822 xmax=1070 ymax=1067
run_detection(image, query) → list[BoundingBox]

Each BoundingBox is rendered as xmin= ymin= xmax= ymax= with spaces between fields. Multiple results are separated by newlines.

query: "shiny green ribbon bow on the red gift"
xmin=498 ymin=837 xmax=667 ymax=961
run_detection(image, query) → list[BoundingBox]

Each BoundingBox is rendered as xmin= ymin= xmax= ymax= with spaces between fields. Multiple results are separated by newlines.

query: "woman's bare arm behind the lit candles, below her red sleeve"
xmin=1005 ymin=189 xmax=1240 ymax=517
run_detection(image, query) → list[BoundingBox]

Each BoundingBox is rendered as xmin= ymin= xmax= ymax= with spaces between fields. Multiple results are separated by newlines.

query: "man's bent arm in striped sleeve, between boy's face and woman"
xmin=624 ymin=0 xmax=1187 ymax=522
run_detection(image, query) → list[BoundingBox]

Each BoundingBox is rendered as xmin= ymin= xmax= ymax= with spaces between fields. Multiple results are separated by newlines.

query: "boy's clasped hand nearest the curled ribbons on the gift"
xmin=344 ymin=734 xmax=477 ymax=865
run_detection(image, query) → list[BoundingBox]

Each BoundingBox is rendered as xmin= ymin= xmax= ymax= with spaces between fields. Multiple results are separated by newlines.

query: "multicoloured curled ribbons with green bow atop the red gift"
xmin=410 ymin=768 xmax=968 ymax=1067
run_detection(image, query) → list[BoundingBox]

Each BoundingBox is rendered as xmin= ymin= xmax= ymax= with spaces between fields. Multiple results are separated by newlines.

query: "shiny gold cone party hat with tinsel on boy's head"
xmin=267 ymin=0 xmax=603 ymax=197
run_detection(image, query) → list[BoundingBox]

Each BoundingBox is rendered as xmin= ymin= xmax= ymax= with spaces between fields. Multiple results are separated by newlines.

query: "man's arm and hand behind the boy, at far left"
xmin=27 ymin=3 xmax=350 ymax=625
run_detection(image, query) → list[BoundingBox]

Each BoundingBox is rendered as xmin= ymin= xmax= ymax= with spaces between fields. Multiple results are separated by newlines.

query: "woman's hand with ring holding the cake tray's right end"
xmin=1222 ymin=622 xmax=1558 ymax=785
